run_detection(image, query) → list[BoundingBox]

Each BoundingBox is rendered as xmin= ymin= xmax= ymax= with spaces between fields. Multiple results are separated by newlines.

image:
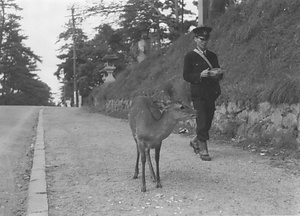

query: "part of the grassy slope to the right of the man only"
xmin=212 ymin=0 xmax=300 ymax=104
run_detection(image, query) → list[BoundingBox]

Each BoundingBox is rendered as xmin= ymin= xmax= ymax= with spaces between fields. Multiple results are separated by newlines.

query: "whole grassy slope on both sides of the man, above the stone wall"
xmin=93 ymin=0 xmax=300 ymax=105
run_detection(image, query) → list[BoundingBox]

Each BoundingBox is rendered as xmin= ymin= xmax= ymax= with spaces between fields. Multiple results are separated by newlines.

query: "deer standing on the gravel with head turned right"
xmin=129 ymin=96 xmax=196 ymax=192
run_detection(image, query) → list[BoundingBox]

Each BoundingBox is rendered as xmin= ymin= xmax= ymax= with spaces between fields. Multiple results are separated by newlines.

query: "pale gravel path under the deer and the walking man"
xmin=44 ymin=108 xmax=300 ymax=216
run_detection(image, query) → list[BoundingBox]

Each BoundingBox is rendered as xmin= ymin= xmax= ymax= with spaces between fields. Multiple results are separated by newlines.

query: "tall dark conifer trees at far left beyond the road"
xmin=0 ymin=0 xmax=51 ymax=105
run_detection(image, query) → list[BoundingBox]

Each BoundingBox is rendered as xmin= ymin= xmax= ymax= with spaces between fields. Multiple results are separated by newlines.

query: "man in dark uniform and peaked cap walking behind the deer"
xmin=183 ymin=26 xmax=223 ymax=161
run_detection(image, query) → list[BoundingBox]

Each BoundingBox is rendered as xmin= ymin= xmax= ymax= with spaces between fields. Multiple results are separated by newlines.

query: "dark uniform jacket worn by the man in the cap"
xmin=183 ymin=50 xmax=223 ymax=101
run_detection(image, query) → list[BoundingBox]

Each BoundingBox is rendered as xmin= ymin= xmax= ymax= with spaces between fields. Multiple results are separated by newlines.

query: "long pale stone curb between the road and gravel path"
xmin=27 ymin=109 xmax=48 ymax=216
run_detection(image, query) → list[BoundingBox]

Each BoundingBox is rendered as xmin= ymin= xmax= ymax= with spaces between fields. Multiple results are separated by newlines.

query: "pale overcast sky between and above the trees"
xmin=15 ymin=0 xmax=197 ymax=103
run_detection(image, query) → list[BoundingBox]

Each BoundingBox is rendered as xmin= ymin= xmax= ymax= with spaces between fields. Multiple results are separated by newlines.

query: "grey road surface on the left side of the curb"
xmin=0 ymin=106 xmax=40 ymax=216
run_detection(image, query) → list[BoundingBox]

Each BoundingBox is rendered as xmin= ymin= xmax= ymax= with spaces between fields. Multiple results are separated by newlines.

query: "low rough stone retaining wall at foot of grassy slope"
xmin=94 ymin=99 xmax=300 ymax=148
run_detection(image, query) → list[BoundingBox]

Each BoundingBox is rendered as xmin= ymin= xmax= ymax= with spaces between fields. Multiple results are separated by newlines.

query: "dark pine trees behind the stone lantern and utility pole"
xmin=54 ymin=0 xmax=199 ymax=104
